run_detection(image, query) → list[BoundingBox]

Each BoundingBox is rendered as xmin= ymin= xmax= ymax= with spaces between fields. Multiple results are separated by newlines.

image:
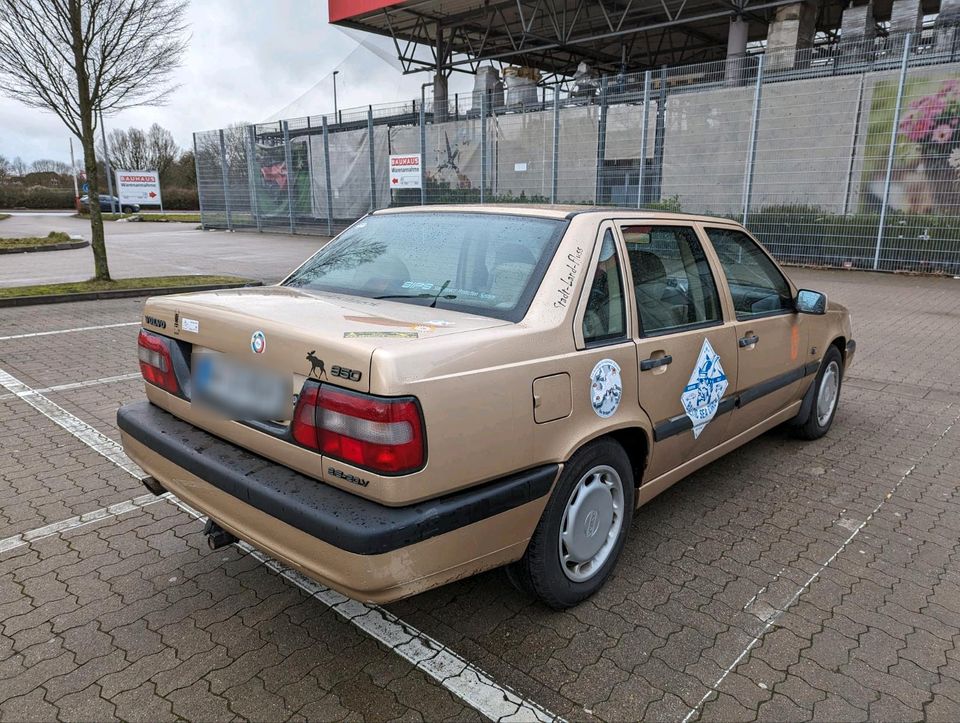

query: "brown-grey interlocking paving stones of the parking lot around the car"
xmin=0 ymin=270 xmax=960 ymax=721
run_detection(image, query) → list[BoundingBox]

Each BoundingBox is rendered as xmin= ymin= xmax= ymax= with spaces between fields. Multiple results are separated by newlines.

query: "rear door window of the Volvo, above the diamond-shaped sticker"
xmin=620 ymin=224 xmax=722 ymax=336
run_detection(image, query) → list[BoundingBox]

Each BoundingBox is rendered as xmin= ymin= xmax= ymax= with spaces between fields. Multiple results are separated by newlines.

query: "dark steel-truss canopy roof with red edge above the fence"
xmin=329 ymin=0 xmax=940 ymax=75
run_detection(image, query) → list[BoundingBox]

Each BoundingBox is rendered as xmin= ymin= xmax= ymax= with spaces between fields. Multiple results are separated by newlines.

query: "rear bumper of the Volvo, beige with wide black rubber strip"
xmin=117 ymin=402 xmax=559 ymax=602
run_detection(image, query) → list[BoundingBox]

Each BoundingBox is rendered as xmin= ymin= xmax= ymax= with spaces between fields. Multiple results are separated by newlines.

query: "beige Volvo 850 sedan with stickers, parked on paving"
xmin=118 ymin=206 xmax=855 ymax=608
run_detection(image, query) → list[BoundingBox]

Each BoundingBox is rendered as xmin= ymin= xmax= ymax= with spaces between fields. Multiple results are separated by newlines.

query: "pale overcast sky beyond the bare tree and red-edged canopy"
xmin=0 ymin=0 xmax=472 ymax=163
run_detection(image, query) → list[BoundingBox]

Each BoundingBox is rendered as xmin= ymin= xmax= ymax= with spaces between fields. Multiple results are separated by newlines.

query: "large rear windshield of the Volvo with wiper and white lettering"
xmin=283 ymin=212 xmax=567 ymax=321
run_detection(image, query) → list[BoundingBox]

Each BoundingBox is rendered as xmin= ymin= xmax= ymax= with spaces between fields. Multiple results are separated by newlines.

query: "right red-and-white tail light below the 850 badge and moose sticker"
xmin=292 ymin=385 xmax=426 ymax=474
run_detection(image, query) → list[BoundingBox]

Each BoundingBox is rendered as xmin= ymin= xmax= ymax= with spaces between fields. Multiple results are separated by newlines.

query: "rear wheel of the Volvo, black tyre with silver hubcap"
xmin=507 ymin=439 xmax=634 ymax=610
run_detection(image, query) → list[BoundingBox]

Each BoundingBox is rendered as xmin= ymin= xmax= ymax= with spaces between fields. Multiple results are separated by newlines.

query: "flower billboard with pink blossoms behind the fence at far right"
xmin=861 ymin=74 xmax=960 ymax=214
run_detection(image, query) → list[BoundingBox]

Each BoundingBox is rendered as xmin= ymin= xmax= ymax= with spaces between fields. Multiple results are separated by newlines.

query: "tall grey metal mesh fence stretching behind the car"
xmin=194 ymin=28 xmax=960 ymax=274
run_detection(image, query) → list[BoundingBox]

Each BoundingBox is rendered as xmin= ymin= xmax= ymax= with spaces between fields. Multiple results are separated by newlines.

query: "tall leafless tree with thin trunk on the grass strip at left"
xmin=0 ymin=0 xmax=188 ymax=280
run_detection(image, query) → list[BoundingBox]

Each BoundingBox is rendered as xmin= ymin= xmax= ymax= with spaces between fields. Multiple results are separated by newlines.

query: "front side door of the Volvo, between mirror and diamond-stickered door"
xmin=704 ymin=224 xmax=807 ymax=434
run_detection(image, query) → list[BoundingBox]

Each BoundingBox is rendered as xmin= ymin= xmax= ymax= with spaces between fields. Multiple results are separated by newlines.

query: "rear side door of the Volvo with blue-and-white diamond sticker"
xmin=617 ymin=219 xmax=737 ymax=481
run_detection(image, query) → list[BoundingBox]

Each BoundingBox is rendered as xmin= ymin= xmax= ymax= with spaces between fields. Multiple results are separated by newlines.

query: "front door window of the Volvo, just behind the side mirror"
xmin=706 ymin=228 xmax=794 ymax=320
